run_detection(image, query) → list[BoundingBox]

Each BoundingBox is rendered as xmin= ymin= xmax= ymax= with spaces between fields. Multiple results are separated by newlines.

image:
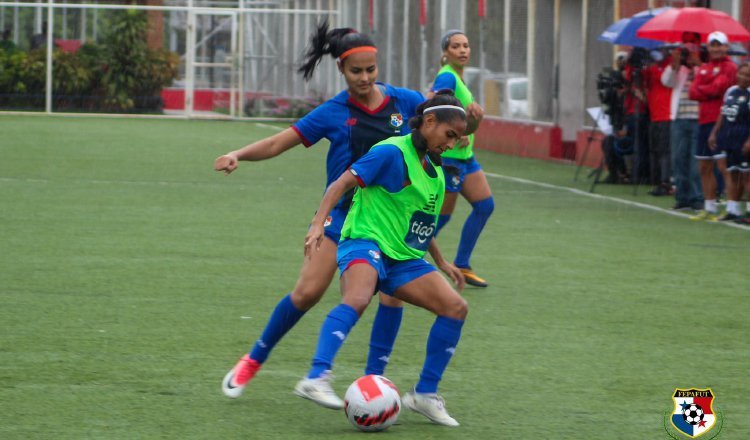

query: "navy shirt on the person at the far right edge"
xmin=716 ymin=85 xmax=750 ymax=151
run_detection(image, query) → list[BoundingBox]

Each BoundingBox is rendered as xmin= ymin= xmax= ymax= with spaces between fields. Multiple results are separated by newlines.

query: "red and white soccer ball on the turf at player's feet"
xmin=344 ymin=374 xmax=401 ymax=431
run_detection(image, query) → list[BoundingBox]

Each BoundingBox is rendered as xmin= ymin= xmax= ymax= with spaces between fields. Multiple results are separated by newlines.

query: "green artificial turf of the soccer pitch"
xmin=0 ymin=115 xmax=750 ymax=440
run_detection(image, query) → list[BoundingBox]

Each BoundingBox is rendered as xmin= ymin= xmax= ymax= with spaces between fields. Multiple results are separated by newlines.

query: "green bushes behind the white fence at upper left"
xmin=0 ymin=10 xmax=179 ymax=112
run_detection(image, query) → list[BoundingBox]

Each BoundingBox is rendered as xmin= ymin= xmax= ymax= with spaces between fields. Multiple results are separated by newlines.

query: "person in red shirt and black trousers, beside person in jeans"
xmin=643 ymin=51 xmax=672 ymax=196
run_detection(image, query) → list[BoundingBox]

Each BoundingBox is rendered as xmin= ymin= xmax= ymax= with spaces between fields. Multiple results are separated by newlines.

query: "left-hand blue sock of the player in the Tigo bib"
xmin=307 ymin=304 xmax=359 ymax=379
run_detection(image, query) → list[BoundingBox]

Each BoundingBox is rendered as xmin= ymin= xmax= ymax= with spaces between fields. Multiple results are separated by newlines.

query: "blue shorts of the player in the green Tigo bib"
xmin=337 ymin=239 xmax=435 ymax=296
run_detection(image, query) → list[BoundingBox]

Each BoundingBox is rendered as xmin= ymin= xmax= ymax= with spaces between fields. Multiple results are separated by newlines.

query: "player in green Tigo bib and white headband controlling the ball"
xmin=294 ymin=91 xmax=468 ymax=426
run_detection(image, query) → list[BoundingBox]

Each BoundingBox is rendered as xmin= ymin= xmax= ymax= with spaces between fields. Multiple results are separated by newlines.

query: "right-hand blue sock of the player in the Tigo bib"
xmin=414 ymin=316 xmax=464 ymax=393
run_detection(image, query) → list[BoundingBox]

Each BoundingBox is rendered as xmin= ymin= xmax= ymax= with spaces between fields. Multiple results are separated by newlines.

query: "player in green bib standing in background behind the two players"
xmin=428 ymin=30 xmax=495 ymax=287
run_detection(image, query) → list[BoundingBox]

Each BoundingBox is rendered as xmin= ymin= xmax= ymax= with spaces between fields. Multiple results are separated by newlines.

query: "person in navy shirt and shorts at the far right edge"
xmin=708 ymin=62 xmax=750 ymax=221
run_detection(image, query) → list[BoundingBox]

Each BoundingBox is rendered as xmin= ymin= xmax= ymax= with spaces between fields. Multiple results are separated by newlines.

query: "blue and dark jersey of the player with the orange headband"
xmin=292 ymin=83 xmax=424 ymax=204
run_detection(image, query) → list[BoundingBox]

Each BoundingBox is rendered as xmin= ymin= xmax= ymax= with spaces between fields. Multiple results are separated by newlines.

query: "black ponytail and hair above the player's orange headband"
xmin=297 ymin=20 xmax=375 ymax=81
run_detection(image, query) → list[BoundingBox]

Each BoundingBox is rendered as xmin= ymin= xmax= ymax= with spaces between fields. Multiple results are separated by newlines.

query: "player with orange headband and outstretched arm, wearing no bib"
xmin=214 ymin=23 xmax=452 ymax=398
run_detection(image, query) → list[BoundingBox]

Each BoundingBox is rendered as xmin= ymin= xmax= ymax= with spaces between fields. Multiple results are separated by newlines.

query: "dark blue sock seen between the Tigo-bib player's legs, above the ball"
xmin=365 ymin=304 xmax=404 ymax=376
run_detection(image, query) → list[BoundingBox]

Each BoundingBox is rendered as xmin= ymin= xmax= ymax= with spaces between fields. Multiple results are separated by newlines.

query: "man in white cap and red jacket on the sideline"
xmin=690 ymin=31 xmax=737 ymax=221
